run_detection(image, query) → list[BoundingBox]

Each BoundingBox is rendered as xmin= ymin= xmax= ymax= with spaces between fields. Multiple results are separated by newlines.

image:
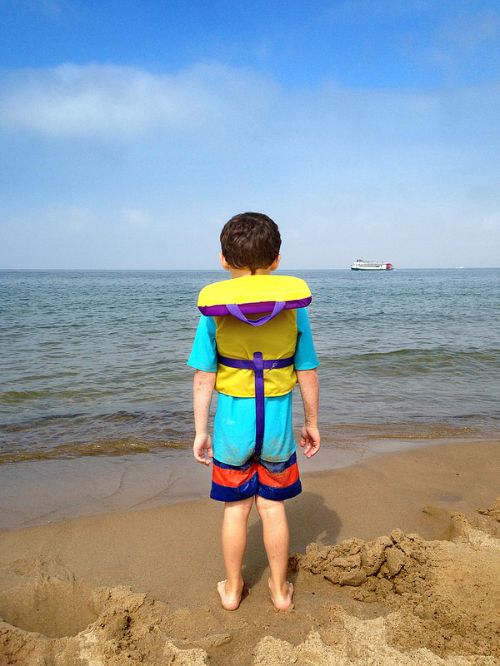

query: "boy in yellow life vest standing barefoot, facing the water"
xmin=188 ymin=213 xmax=320 ymax=610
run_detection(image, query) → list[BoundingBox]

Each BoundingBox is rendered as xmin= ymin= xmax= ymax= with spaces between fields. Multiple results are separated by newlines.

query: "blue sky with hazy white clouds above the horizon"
xmin=0 ymin=0 xmax=500 ymax=269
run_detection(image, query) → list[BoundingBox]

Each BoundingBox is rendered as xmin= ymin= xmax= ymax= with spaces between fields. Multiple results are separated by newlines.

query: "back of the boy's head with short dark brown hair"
xmin=220 ymin=213 xmax=281 ymax=275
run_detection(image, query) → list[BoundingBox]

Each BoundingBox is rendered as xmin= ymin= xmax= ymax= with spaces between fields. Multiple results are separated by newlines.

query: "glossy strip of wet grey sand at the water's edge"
xmin=0 ymin=428 xmax=492 ymax=531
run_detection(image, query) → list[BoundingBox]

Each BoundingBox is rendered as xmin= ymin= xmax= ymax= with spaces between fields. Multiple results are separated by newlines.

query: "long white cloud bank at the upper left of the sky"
xmin=0 ymin=64 xmax=273 ymax=138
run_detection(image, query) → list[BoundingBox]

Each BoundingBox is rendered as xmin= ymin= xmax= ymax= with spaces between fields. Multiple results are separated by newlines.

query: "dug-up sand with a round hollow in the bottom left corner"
xmin=0 ymin=560 xmax=210 ymax=666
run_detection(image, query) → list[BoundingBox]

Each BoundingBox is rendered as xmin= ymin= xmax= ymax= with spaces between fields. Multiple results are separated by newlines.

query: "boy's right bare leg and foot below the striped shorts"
xmin=255 ymin=495 xmax=293 ymax=610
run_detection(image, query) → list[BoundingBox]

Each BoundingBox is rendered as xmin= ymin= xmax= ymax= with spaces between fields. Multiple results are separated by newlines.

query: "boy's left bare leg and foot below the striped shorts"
xmin=217 ymin=497 xmax=254 ymax=610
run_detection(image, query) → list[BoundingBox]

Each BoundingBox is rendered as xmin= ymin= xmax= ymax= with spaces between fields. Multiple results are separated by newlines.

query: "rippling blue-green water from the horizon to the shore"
xmin=0 ymin=269 xmax=500 ymax=463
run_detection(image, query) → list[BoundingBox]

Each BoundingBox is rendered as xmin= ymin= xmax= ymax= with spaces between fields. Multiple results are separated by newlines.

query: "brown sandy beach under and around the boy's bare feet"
xmin=0 ymin=441 xmax=500 ymax=666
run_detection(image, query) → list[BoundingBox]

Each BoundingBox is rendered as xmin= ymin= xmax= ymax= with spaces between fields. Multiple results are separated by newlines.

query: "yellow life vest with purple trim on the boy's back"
xmin=198 ymin=275 xmax=312 ymax=398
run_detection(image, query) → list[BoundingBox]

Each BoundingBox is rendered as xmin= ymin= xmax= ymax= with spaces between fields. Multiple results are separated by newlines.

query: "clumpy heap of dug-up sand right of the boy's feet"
xmin=284 ymin=498 xmax=500 ymax=665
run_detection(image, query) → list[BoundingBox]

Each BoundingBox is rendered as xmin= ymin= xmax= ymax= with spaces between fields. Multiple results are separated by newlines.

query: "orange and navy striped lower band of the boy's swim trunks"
xmin=210 ymin=451 xmax=302 ymax=502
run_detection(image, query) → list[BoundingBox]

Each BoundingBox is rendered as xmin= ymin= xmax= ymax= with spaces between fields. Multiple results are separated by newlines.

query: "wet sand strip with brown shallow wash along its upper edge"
xmin=0 ymin=423 xmax=486 ymax=531
